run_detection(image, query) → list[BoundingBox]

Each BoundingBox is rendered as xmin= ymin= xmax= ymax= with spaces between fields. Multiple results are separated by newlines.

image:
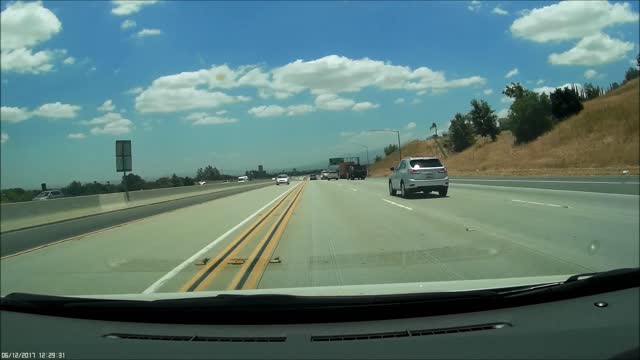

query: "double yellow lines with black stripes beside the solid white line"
xmin=180 ymin=182 xmax=306 ymax=292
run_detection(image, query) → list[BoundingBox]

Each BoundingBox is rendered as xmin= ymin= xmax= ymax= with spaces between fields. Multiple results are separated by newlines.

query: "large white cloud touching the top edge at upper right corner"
xmin=511 ymin=1 xmax=638 ymax=42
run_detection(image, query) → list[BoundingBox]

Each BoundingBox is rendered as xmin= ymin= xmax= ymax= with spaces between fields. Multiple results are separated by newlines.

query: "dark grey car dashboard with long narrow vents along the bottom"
xmin=0 ymin=287 xmax=640 ymax=359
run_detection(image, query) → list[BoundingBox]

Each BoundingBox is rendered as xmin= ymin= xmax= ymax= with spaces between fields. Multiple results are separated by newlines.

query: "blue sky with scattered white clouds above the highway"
xmin=0 ymin=1 xmax=639 ymax=188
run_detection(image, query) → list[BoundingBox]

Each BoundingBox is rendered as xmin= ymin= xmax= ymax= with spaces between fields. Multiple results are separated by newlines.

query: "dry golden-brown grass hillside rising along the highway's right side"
xmin=370 ymin=79 xmax=640 ymax=176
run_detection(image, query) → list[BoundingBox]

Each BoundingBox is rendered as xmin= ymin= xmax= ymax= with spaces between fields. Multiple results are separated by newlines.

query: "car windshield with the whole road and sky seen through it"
xmin=0 ymin=0 xmax=640 ymax=306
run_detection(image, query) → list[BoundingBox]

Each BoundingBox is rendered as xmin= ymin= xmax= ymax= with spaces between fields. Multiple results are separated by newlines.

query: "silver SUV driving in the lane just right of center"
xmin=389 ymin=157 xmax=449 ymax=197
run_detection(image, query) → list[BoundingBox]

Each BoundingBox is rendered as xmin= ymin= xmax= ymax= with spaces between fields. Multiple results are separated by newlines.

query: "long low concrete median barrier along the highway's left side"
xmin=0 ymin=180 xmax=271 ymax=233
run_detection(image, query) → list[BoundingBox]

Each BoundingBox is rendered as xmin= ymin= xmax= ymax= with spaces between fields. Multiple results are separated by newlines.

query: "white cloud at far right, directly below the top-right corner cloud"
xmin=549 ymin=33 xmax=634 ymax=66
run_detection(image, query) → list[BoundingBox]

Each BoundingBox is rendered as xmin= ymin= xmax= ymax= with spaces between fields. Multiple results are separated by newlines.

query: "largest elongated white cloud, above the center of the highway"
xmin=271 ymin=55 xmax=486 ymax=95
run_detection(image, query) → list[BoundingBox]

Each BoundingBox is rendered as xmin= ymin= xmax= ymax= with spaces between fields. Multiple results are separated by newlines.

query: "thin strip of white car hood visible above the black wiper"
xmin=69 ymin=274 xmax=574 ymax=301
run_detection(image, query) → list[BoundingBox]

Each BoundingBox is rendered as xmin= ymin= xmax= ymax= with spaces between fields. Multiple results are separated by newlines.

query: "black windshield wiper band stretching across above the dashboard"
xmin=0 ymin=268 xmax=640 ymax=324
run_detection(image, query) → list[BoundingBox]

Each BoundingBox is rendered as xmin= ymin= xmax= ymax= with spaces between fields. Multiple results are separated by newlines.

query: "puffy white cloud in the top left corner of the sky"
xmin=0 ymin=1 xmax=66 ymax=74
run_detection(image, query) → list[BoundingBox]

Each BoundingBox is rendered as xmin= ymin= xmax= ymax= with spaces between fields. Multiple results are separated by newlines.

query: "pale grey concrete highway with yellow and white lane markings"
xmin=0 ymin=177 xmax=640 ymax=295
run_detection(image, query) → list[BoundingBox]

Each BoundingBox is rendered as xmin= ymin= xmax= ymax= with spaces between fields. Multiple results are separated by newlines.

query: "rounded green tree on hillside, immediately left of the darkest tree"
xmin=509 ymin=92 xmax=553 ymax=143
